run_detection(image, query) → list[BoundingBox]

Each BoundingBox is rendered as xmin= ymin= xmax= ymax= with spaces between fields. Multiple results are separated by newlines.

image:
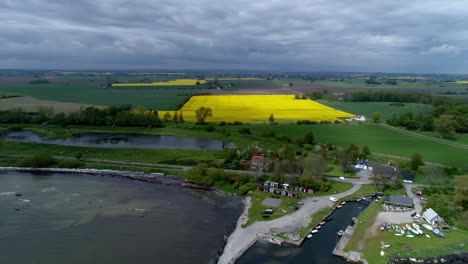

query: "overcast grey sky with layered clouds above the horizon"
xmin=0 ymin=0 xmax=468 ymax=73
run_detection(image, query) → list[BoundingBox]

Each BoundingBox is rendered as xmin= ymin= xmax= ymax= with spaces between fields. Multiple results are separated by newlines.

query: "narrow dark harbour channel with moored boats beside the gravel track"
xmin=236 ymin=202 xmax=368 ymax=264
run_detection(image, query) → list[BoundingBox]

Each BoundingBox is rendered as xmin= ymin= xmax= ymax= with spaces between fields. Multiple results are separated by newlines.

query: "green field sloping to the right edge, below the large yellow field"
xmin=245 ymin=124 xmax=468 ymax=166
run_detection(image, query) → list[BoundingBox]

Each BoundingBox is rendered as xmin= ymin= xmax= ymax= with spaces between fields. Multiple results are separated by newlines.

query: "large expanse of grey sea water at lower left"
xmin=0 ymin=172 xmax=242 ymax=264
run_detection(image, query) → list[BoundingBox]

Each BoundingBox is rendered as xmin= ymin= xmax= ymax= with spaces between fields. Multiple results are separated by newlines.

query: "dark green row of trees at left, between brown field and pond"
xmin=0 ymin=105 xmax=162 ymax=127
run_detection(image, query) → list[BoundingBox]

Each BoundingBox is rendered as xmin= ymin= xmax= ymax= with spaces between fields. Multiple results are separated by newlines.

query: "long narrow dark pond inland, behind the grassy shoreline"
xmin=3 ymin=131 xmax=228 ymax=150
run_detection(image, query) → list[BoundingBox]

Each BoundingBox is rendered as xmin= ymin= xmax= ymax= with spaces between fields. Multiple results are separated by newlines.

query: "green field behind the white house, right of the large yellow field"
xmin=317 ymin=100 xmax=432 ymax=121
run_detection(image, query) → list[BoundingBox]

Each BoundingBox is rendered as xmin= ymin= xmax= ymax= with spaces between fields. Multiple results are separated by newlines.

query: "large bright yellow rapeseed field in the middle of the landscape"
xmin=159 ymin=95 xmax=354 ymax=123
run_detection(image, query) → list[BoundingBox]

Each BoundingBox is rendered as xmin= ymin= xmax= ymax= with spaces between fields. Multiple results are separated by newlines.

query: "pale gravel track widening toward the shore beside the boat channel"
xmin=218 ymin=184 xmax=361 ymax=264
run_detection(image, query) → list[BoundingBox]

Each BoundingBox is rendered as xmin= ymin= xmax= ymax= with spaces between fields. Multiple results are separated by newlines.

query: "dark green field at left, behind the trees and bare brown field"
xmin=0 ymin=83 xmax=192 ymax=109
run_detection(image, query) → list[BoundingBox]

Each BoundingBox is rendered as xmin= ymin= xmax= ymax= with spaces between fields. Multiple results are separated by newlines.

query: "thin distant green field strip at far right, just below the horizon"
xmin=315 ymin=79 xmax=468 ymax=90
